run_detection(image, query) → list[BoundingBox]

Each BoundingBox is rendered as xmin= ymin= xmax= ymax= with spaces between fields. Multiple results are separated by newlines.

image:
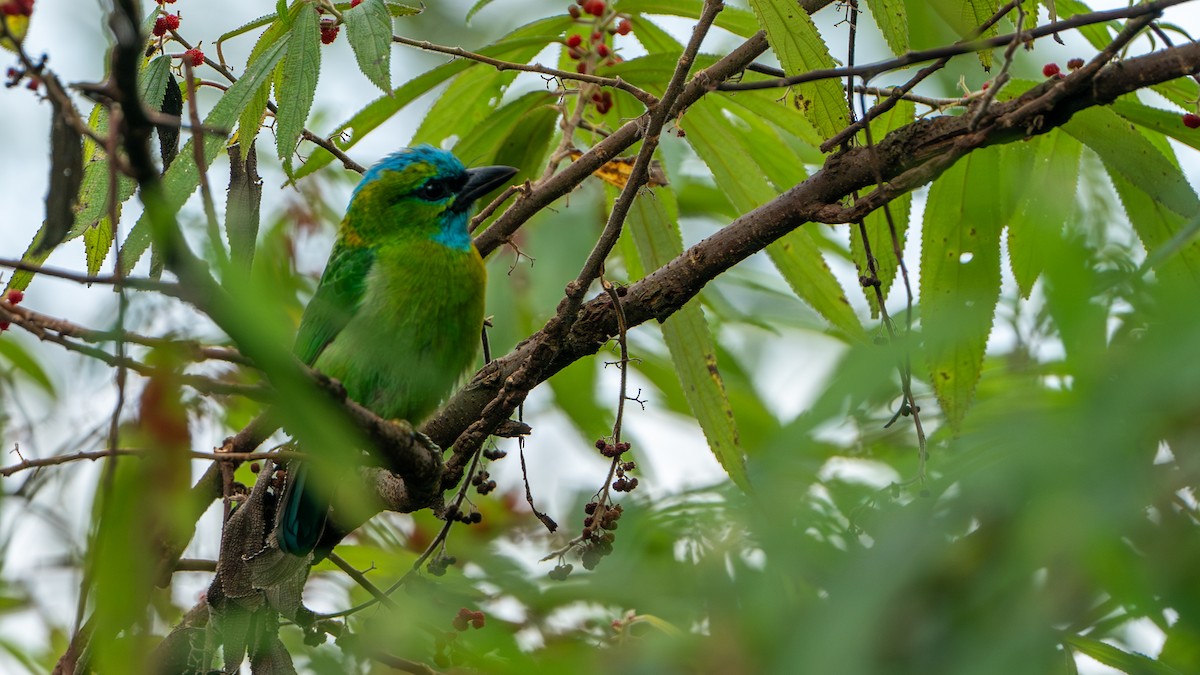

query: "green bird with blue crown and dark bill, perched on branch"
xmin=275 ymin=145 xmax=517 ymax=556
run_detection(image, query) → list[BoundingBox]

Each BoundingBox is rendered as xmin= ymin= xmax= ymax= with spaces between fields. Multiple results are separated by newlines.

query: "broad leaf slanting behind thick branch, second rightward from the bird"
xmin=686 ymin=98 xmax=863 ymax=339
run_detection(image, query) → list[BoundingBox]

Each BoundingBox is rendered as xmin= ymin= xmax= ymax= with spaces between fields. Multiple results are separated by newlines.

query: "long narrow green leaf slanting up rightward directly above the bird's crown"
xmin=295 ymin=16 xmax=572 ymax=178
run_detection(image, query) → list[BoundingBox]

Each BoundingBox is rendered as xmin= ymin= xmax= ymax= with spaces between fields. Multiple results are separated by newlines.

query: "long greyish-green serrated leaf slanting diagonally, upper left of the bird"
xmin=121 ymin=32 xmax=290 ymax=274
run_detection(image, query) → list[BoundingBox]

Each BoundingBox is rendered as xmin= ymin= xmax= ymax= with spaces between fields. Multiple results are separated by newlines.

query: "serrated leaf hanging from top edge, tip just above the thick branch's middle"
xmin=750 ymin=0 xmax=850 ymax=138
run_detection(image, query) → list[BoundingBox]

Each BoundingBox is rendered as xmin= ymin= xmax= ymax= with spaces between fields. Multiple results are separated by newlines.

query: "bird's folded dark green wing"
xmin=295 ymin=243 xmax=374 ymax=365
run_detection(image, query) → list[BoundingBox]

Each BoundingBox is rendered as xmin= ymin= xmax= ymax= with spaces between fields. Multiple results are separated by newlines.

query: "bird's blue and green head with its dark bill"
xmin=347 ymin=145 xmax=516 ymax=251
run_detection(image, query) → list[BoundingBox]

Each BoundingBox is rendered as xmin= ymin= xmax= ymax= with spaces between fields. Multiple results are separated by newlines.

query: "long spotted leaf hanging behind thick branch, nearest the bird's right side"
xmin=626 ymin=190 xmax=750 ymax=490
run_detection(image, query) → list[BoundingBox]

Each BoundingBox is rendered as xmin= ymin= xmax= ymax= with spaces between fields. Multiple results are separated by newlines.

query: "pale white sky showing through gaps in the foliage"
xmin=0 ymin=0 xmax=1200 ymax=675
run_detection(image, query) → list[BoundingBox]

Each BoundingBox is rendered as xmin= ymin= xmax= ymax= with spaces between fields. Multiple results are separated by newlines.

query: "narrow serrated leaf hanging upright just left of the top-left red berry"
xmin=274 ymin=6 xmax=321 ymax=175
